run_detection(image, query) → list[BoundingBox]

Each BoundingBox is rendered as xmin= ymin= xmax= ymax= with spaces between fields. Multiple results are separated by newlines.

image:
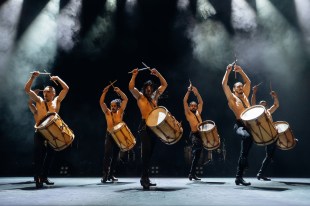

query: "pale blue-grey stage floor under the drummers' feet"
xmin=0 ymin=177 xmax=310 ymax=206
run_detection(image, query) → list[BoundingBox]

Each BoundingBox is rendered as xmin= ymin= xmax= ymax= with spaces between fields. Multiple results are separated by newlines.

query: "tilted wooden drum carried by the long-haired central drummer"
xmin=146 ymin=106 xmax=183 ymax=145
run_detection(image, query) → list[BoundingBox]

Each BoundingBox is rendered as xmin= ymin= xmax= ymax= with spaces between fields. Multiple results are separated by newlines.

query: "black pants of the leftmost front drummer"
xmin=33 ymin=132 xmax=55 ymax=179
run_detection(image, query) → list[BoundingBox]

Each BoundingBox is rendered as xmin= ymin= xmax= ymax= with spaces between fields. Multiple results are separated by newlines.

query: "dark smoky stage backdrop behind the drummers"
xmin=0 ymin=0 xmax=310 ymax=177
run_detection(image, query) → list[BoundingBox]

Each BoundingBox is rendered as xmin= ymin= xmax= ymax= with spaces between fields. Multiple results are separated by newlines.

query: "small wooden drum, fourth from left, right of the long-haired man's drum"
xmin=197 ymin=120 xmax=221 ymax=150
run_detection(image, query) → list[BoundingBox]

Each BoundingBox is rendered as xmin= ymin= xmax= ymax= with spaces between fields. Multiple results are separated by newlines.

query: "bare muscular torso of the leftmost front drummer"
xmin=34 ymin=97 xmax=60 ymax=126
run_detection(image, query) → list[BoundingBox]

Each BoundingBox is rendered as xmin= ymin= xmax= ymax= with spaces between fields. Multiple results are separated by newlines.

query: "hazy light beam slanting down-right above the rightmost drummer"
xmin=256 ymin=0 xmax=303 ymax=83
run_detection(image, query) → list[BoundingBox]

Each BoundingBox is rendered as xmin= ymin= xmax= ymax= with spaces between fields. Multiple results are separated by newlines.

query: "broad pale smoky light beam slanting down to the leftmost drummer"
xmin=1 ymin=0 xmax=59 ymax=124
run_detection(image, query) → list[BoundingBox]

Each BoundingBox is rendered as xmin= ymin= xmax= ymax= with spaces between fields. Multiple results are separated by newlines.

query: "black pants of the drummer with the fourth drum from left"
xmin=189 ymin=132 xmax=203 ymax=175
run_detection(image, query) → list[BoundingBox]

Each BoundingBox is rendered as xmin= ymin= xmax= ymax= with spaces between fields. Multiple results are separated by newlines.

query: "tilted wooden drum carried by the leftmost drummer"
xmin=35 ymin=112 xmax=75 ymax=151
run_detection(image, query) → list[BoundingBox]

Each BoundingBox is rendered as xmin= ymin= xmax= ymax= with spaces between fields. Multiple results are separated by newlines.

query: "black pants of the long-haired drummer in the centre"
xmin=138 ymin=119 xmax=157 ymax=178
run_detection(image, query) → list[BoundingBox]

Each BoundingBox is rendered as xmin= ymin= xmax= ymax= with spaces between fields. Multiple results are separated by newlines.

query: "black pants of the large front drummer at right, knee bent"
xmin=234 ymin=120 xmax=253 ymax=177
